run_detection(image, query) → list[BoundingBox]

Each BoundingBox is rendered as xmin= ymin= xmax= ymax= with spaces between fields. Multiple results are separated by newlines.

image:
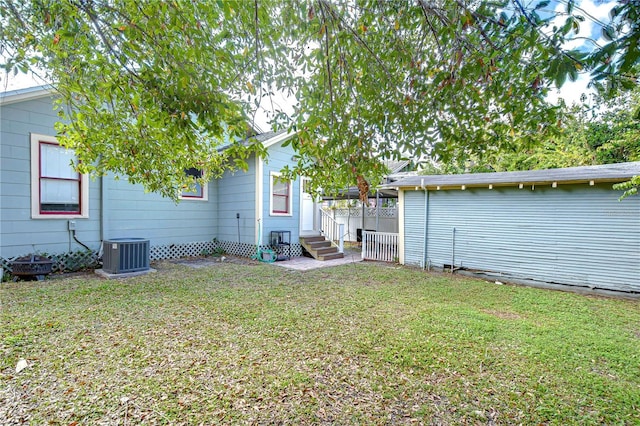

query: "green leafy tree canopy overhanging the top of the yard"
xmin=0 ymin=0 xmax=640 ymax=198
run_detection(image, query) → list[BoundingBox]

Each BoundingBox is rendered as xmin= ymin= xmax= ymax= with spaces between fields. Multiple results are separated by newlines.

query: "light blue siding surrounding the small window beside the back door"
xmin=262 ymin=142 xmax=300 ymax=244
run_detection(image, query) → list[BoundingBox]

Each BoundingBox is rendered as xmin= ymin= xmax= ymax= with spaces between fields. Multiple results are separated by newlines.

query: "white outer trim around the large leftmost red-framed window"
xmin=31 ymin=133 xmax=89 ymax=219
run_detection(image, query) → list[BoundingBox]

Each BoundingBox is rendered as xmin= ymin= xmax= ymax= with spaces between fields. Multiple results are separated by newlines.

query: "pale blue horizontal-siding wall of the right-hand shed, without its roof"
xmin=405 ymin=184 xmax=640 ymax=291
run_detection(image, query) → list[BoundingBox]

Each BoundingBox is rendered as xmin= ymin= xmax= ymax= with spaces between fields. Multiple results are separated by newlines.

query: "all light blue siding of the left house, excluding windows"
xmin=0 ymin=92 xmax=300 ymax=258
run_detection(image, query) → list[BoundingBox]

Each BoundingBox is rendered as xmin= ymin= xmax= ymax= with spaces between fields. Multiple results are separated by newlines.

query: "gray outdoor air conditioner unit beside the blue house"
xmin=102 ymin=238 xmax=149 ymax=274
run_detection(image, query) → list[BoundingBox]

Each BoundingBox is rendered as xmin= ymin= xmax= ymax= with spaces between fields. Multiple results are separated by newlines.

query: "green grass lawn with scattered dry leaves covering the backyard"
xmin=0 ymin=263 xmax=640 ymax=425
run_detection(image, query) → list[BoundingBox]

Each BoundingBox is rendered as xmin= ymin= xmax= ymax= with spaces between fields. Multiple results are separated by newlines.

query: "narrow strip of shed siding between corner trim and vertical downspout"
xmin=404 ymin=191 xmax=425 ymax=266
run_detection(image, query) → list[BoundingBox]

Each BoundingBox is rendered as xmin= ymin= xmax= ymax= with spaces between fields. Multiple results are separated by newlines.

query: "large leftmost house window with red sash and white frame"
xmin=31 ymin=133 xmax=89 ymax=219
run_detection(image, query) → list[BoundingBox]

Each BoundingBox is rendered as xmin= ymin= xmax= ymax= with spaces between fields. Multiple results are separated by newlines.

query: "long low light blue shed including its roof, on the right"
xmin=387 ymin=162 xmax=640 ymax=294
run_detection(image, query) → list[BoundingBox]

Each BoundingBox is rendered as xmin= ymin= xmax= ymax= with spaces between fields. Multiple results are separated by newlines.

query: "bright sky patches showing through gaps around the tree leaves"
xmin=0 ymin=0 xmax=615 ymax=113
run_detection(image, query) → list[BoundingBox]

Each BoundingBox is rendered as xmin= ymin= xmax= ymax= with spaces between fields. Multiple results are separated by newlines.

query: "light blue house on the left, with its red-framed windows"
xmin=0 ymin=87 xmax=317 ymax=267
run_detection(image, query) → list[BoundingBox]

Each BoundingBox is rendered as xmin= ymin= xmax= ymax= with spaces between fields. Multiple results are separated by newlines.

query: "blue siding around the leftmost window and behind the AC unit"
xmin=0 ymin=97 xmax=217 ymax=258
